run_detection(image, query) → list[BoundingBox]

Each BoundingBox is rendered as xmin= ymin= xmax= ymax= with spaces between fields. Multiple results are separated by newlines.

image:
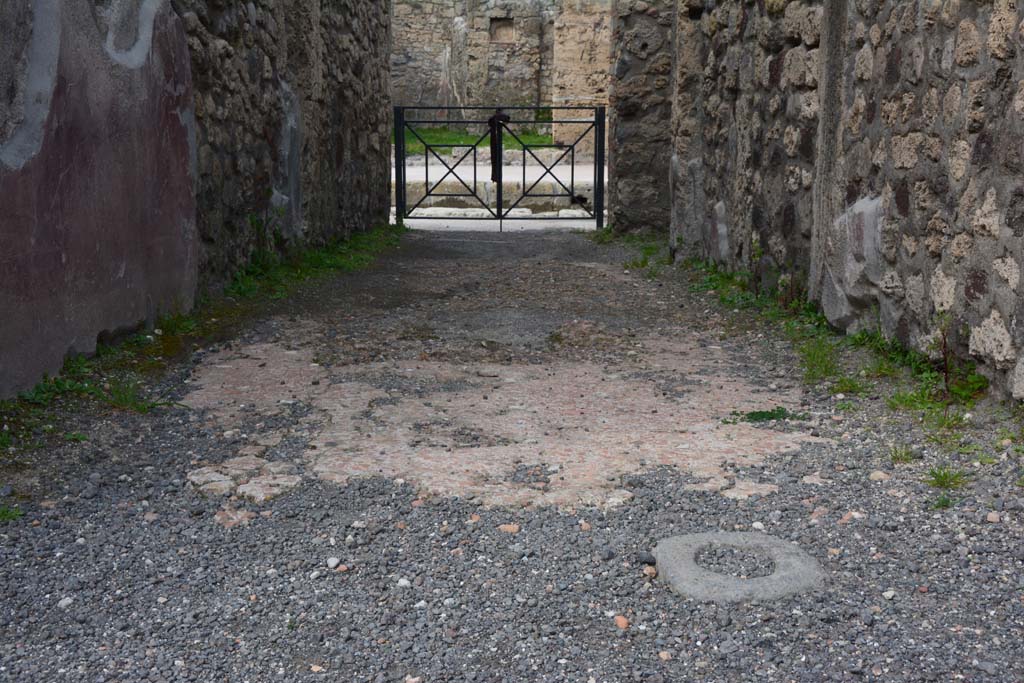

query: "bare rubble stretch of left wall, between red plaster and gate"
xmin=174 ymin=0 xmax=391 ymax=286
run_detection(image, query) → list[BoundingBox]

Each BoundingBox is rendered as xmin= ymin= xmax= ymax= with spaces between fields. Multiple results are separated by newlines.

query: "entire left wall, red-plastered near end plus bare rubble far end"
xmin=0 ymin=0 xmax=390 ymax=397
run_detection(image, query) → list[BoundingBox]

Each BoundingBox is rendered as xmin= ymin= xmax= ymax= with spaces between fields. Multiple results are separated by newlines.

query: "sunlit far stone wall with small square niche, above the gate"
xmin=391 ymin=0 xmax=611 ymax=116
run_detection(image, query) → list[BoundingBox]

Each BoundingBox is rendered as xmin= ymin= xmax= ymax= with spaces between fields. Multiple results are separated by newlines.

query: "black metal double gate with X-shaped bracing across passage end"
xmin=394 ymin=106 xmax=605 ymax=229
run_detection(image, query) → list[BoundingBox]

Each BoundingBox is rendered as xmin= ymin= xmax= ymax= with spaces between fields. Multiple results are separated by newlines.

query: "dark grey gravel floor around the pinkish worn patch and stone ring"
xmin=0 ymin=233 xmax=1024 ymax=683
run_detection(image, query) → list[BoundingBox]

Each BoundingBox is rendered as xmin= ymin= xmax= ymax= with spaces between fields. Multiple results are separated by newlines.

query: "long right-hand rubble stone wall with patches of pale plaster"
xmin=672 ymin=0 xmax=1024 ymax=397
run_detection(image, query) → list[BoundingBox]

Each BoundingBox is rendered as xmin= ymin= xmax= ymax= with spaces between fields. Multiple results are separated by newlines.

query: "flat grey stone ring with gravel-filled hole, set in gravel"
xmin=654 ymin=531 xmax=825 ymax=602
